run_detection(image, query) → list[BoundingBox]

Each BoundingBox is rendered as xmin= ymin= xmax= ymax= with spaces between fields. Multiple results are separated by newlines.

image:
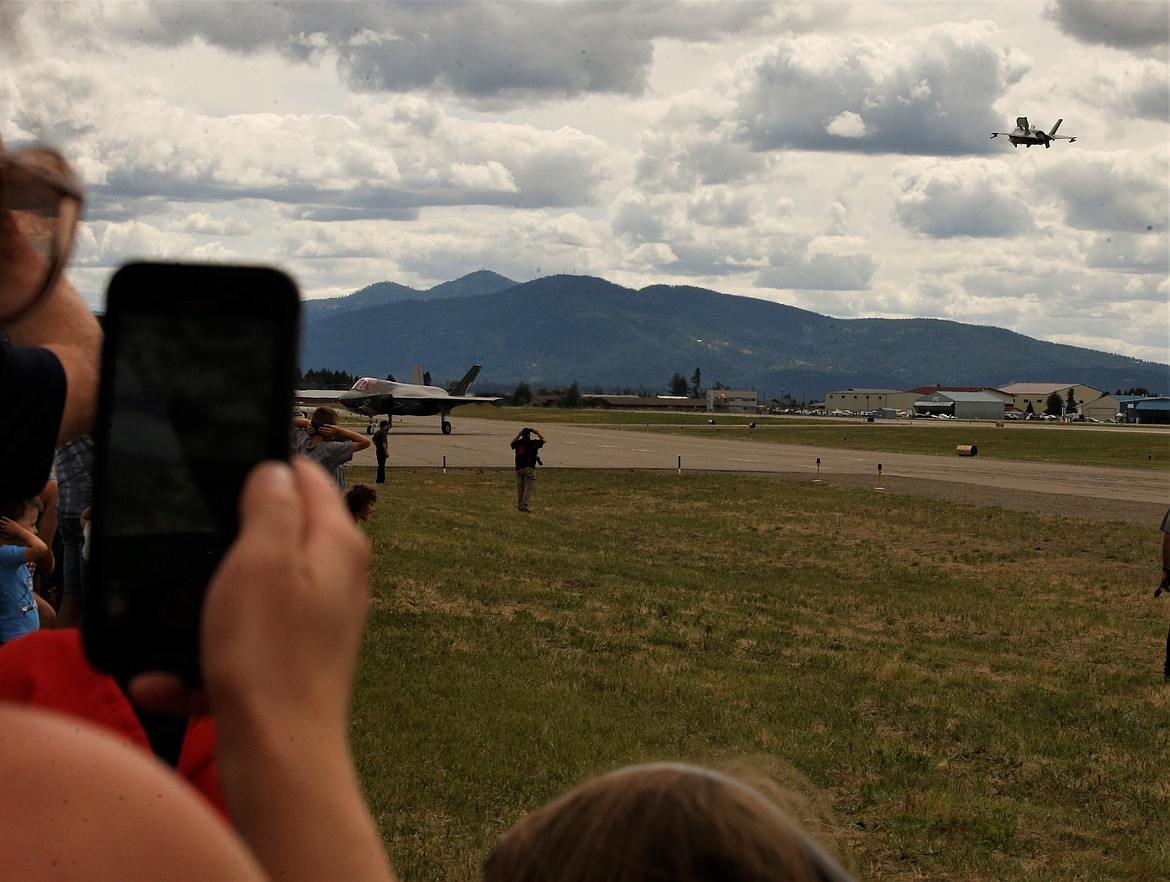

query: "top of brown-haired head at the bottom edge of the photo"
xmin=482 ymin=763 xmax=852 ymax=882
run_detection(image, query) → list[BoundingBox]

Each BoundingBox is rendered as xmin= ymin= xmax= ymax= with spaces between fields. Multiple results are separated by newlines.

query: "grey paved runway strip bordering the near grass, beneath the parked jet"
xmin=355 ymin=412 xmax=1170 ymax=505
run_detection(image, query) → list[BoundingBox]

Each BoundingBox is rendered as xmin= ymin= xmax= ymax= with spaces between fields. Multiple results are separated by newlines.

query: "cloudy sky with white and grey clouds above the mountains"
xmin=0 ymin=0 xmax=1170 ymax=363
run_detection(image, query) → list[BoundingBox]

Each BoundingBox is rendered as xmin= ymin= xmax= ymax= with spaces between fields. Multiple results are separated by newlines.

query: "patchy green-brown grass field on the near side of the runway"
xmin=341 ymin=463 xmax=1170 ymax=882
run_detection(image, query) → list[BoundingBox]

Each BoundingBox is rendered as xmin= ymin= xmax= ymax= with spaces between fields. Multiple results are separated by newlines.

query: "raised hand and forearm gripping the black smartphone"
xmin=131 ymin=460 xmax=393 ymax=882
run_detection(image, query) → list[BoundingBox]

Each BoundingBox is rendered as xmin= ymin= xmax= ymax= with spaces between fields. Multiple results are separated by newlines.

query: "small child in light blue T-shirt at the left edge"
xmin=0 ymin=499 xmax=51 ymax=643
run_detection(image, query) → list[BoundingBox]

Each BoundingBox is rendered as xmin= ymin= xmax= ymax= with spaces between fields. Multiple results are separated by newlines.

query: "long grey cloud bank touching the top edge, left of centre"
xmin=100 ymin=0 xmax=786 ymax=108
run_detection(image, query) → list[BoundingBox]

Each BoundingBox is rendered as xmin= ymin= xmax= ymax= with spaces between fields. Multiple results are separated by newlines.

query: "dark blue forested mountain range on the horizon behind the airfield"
xmin=301 ymin=270 xmax=1170 ymax=399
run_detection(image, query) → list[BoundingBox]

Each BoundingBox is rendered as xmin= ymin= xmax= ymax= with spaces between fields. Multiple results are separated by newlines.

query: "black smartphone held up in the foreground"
xmin=82 ymin=257 xmax=300 ymax=684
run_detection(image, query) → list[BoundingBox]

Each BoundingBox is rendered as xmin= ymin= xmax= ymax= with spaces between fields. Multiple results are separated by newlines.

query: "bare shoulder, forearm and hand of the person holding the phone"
xmin=0 ymin=461 xmax=393 ymax=880
